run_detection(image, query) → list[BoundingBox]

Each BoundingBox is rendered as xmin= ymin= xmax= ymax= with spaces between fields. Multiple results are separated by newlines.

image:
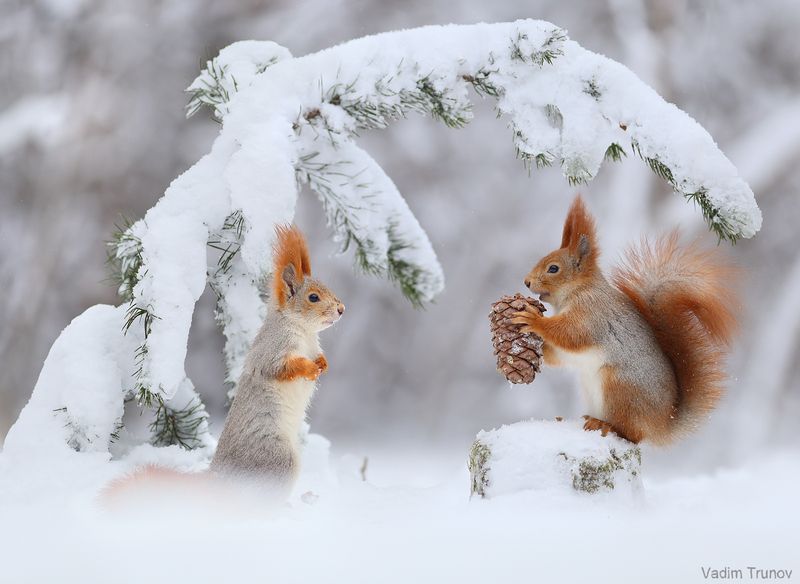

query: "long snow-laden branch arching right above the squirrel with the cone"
xmin=198 ymin=21 xmax=761 ymax=241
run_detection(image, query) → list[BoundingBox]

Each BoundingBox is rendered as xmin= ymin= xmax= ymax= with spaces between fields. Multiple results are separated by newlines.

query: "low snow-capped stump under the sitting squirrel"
xmin=469 ymin=420 xmax=642 ymax=498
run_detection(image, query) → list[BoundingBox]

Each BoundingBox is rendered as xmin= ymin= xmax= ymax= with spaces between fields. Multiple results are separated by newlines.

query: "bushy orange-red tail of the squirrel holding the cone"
xmin=613 ymin=232 xmax=739 ymax=434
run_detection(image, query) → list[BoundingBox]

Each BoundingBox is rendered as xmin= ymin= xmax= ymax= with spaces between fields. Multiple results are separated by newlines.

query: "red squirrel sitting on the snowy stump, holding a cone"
xmin=512 ymin=197 xmax=739 ymax=444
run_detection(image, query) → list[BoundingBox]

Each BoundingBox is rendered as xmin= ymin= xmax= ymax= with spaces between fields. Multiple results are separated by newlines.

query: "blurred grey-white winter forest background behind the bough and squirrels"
xmin=0 ymin=0 xmax=800 ymax=470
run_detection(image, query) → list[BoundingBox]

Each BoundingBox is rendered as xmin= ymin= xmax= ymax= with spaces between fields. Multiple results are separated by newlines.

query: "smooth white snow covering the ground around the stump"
xmin=0 ymin=439 xmax=800 ymax=583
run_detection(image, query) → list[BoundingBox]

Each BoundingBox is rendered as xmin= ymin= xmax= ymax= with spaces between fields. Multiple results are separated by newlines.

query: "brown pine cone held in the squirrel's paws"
xmin=489 ymin=294 xmax=545 ymax=383
